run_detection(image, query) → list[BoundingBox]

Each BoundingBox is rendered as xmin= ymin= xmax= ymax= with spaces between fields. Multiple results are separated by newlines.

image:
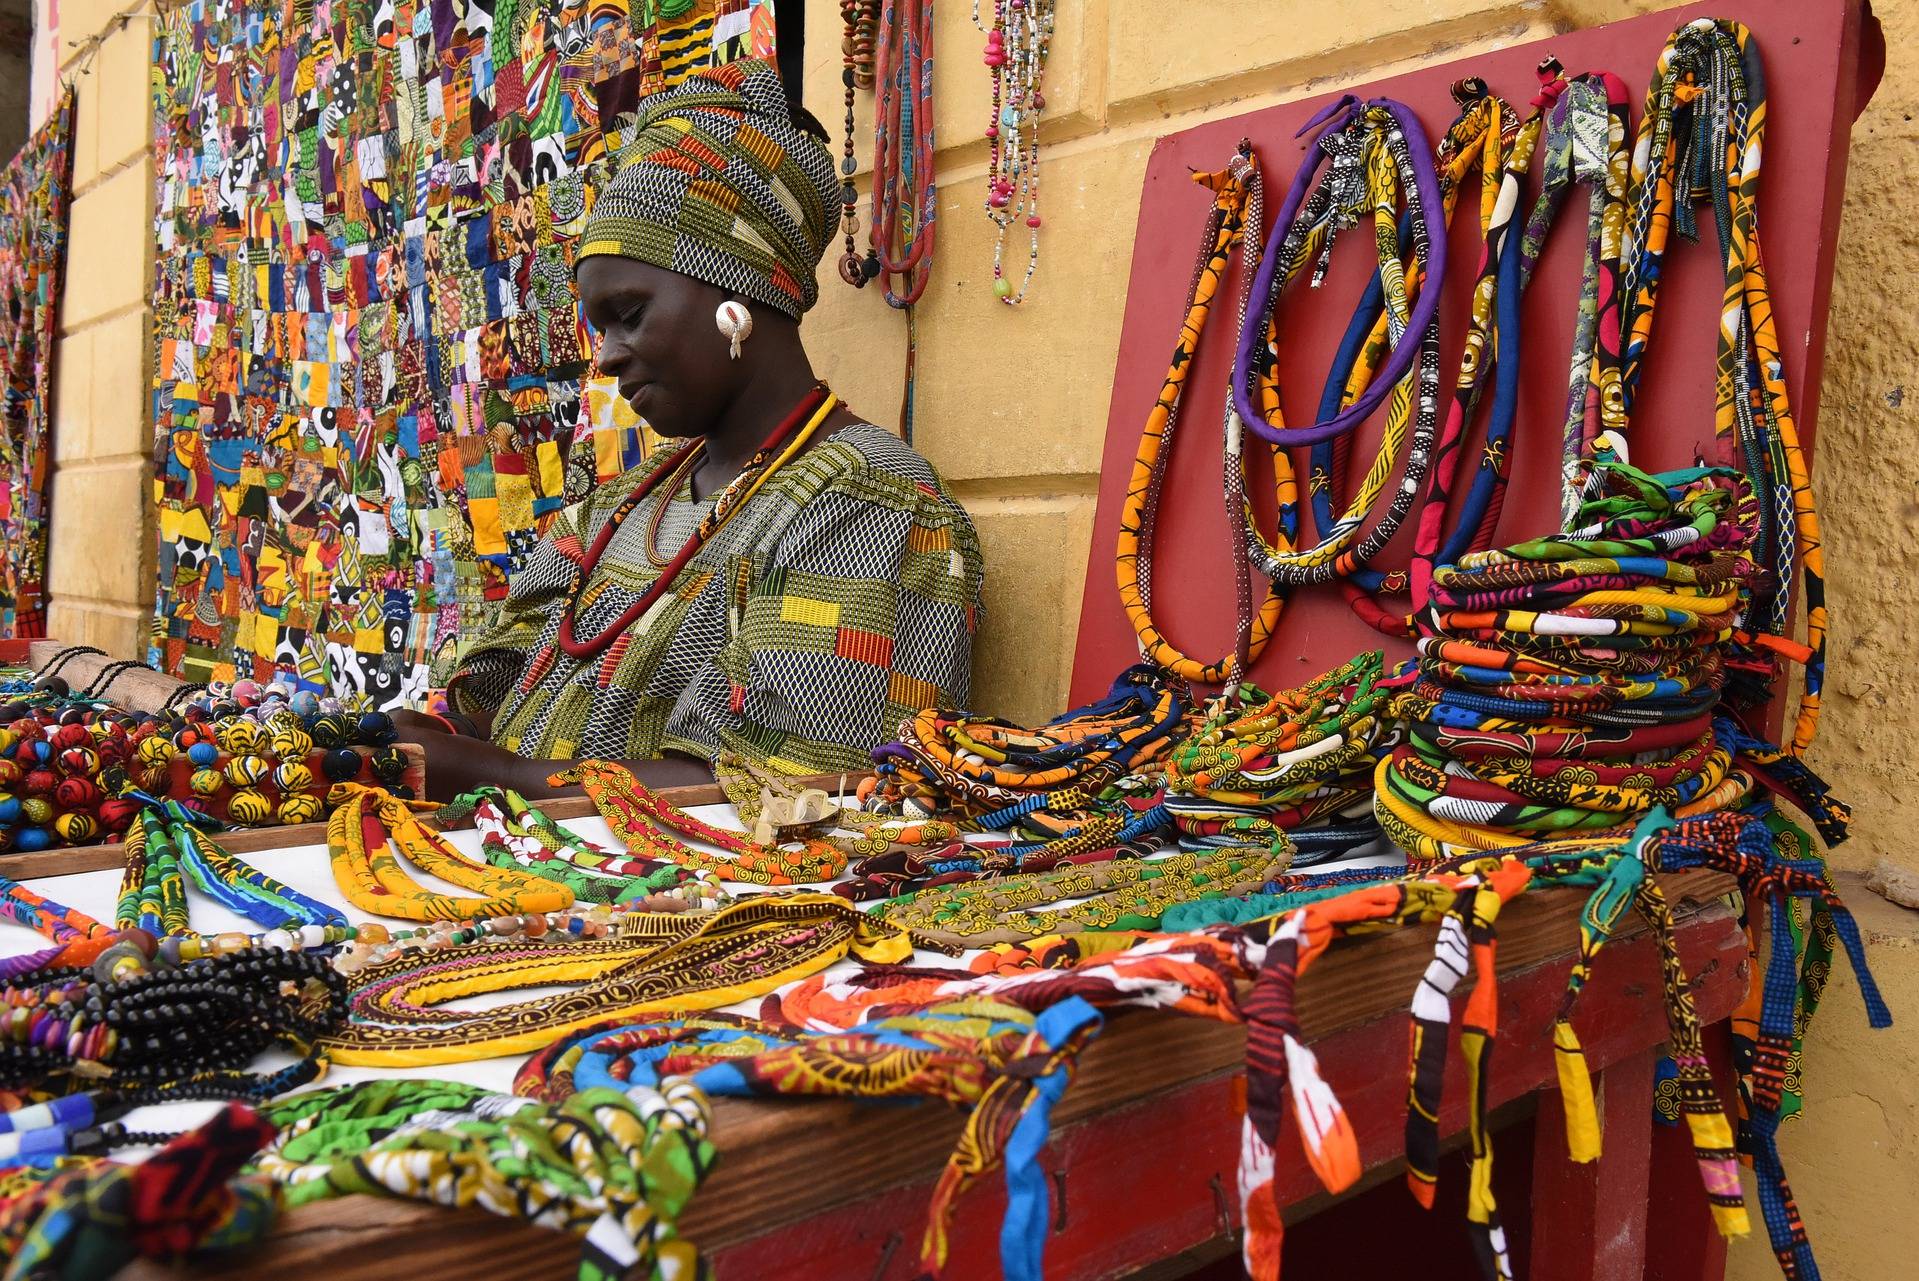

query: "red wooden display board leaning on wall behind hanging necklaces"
xmin=1073 ymin=0 xmax=1883 ymax=704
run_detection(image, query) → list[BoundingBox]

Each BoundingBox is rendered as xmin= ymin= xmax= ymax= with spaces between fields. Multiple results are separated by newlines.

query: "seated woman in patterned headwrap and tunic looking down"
xmin=403 ymin=61 xmax=981 ymax=798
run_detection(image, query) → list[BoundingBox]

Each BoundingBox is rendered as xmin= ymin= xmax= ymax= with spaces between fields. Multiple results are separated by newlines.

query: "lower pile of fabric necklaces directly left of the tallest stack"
xmin=1165 ymin=650 xmax=1397 ymax=871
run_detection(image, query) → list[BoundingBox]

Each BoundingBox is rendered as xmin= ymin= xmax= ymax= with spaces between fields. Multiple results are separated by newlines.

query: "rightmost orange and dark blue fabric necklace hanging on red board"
xmin=1622 ymin=19 xmax=1829 ymax=754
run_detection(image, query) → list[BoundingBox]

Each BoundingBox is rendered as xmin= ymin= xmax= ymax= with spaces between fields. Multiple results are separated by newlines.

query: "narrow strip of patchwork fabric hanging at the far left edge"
xmin=0 ymin=88 xmax=73 ymax=637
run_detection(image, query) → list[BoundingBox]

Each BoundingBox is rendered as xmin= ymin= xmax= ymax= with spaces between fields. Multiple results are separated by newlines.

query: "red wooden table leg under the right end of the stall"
xmin=1524 ymin=1049 xmax=1660 ymax=1281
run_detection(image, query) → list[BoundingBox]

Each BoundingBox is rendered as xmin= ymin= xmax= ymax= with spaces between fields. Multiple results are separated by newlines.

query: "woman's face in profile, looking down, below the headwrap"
xmin=578 ymin=255 xmax=745 ymax=437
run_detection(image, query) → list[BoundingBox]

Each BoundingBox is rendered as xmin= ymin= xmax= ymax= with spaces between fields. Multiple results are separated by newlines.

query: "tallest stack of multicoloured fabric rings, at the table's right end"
xmin=1374 ymin=453 xmax=1756 ymax=859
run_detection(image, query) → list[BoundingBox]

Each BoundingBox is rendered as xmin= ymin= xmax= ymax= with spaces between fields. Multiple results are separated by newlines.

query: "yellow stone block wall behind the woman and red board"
xmin=26 ymin=0 xmax=1919 ymax=1281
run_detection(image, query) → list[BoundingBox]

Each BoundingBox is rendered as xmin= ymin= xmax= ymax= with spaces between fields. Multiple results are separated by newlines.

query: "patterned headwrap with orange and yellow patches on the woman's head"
xmin=578 ymin=58 xmax=841 ymax=320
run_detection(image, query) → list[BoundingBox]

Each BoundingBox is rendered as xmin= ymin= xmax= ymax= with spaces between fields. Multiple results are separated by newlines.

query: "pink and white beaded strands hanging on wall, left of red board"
xmin=973 ymin=0 xmax=1055 ymax=307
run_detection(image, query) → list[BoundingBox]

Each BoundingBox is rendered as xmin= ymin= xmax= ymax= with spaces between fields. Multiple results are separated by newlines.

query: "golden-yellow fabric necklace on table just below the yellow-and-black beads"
xmin=326 ymin=782 xmax=574 ymax=920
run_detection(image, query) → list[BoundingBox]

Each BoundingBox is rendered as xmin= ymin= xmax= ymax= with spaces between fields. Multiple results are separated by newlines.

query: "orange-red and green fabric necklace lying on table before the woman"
xmin=549 ymin=761 xmax=846 ymax=886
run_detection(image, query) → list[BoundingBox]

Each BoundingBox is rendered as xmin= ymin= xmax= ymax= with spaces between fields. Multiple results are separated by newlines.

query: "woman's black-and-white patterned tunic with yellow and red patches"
xmin=449 ymin=424 xmax=983 ymax=773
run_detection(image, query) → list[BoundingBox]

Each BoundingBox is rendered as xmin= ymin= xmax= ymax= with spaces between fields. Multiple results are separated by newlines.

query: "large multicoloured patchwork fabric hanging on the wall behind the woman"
xmin=152 ymin=0 xmax=773 ymax=706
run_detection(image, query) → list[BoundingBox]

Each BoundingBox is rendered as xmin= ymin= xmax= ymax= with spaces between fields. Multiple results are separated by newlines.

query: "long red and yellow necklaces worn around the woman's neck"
xmin=552 ymin=384 xmax=839 ymax=659
